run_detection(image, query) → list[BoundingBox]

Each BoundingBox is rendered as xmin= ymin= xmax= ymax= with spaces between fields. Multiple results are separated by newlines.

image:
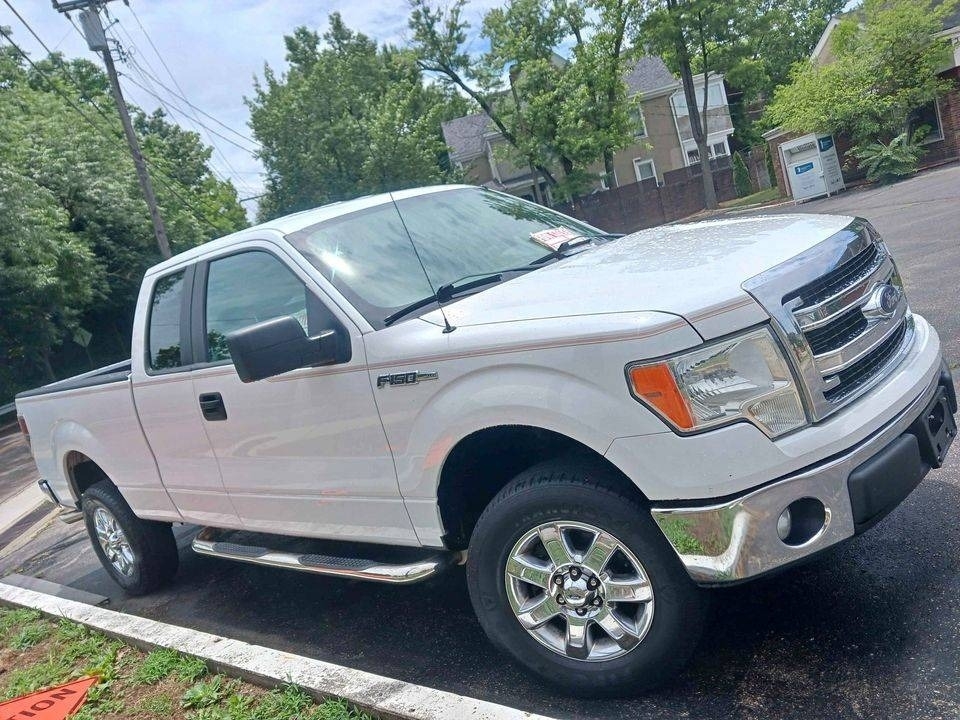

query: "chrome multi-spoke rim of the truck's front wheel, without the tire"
xmin=505 ymin=521 xmax=653 ymax=662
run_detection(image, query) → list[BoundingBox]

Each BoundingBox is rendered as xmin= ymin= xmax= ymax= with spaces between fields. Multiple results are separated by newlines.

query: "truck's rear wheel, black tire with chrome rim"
xmin=81 ymin=480 xmax=180 ymax=595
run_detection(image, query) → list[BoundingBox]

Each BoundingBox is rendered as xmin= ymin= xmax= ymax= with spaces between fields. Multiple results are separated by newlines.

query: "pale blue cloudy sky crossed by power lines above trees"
xmin=0 ymin=0 xmax=499 ymax=215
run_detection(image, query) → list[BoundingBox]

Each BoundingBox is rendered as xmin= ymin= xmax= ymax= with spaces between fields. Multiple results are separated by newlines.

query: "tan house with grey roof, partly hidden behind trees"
xmin=442 ymin=55 xmax=733 ymax=199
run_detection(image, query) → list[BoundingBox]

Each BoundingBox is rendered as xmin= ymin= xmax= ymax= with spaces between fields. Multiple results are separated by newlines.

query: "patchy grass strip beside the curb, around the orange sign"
xmin=0 ymin=608 xmax=373 ymax=720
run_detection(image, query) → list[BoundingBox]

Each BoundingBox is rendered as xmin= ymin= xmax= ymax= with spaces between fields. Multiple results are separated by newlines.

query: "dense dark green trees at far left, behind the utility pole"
xmin=0 ymin=39 xmax=246 ymax=402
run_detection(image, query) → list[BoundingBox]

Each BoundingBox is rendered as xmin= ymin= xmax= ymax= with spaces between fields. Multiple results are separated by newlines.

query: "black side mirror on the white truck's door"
xmin=227 ymin=315 xmax=341 ymax=383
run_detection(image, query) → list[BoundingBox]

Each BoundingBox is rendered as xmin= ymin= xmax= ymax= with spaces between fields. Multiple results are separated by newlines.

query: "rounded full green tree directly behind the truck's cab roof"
xmin=247 ymin=13 xmax=469 ymax=219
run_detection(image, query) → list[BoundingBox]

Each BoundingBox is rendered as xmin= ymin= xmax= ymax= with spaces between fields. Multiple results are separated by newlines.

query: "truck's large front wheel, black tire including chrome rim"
xmin=467 ymin=458 xmax=706 ymax=696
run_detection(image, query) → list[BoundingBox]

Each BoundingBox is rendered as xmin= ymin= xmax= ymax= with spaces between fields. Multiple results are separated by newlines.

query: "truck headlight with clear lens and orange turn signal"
xmin=627 ymin=328 xmax=807 ymax=437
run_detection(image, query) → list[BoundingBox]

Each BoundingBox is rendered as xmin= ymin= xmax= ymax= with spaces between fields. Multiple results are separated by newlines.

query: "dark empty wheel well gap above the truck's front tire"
xmin=437 ymin=425 xmax=646 ymax=550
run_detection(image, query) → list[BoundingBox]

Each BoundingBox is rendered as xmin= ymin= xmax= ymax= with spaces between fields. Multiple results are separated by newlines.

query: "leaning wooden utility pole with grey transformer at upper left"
xmin=51 ymin=0 xmax=173 ymax=258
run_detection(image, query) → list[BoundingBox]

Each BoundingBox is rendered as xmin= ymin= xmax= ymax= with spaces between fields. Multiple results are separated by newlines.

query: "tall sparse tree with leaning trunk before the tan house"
xmin=410 ymin=0 xmax=642 ymax=197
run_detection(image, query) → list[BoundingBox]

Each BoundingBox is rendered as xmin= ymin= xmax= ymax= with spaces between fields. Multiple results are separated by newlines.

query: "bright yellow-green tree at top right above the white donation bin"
xmin=765 ymin=0 xmax=956 ymax=145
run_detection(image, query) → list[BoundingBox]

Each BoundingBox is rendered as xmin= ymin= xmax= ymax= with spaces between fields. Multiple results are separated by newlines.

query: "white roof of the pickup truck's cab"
xmin=145 ymin=185 xmax=474 ymax=276
